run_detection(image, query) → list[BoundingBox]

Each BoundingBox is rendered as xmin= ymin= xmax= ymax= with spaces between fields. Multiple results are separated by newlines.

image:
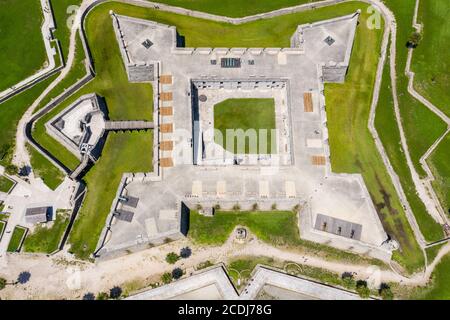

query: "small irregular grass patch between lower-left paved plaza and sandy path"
xmin=23 ymin=212 xmax=70 ymax=253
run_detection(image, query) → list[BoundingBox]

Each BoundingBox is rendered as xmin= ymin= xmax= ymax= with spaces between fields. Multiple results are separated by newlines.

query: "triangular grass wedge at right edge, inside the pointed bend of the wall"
xmin=428 ymin=134 xmax=450 ymax=214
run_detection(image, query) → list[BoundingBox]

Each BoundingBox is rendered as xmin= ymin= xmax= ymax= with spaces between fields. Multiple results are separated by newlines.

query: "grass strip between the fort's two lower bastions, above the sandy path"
xmin=188 ymin=211 xmax=300 ymax=245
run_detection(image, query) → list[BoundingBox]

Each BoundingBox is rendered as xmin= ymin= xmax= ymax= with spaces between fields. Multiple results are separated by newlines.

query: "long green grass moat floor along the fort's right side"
xmin=325 ymin=10 xmax=424 ymax=271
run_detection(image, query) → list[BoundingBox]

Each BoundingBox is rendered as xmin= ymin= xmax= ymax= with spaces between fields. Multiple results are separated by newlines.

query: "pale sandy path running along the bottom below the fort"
xmin=0 ymin=225 xmax=444 ymax=299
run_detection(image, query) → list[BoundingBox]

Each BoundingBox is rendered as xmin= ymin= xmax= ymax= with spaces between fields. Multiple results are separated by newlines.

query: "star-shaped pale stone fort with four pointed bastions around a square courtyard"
xmin=91 ymin=12 xmax=395 ymax=261
